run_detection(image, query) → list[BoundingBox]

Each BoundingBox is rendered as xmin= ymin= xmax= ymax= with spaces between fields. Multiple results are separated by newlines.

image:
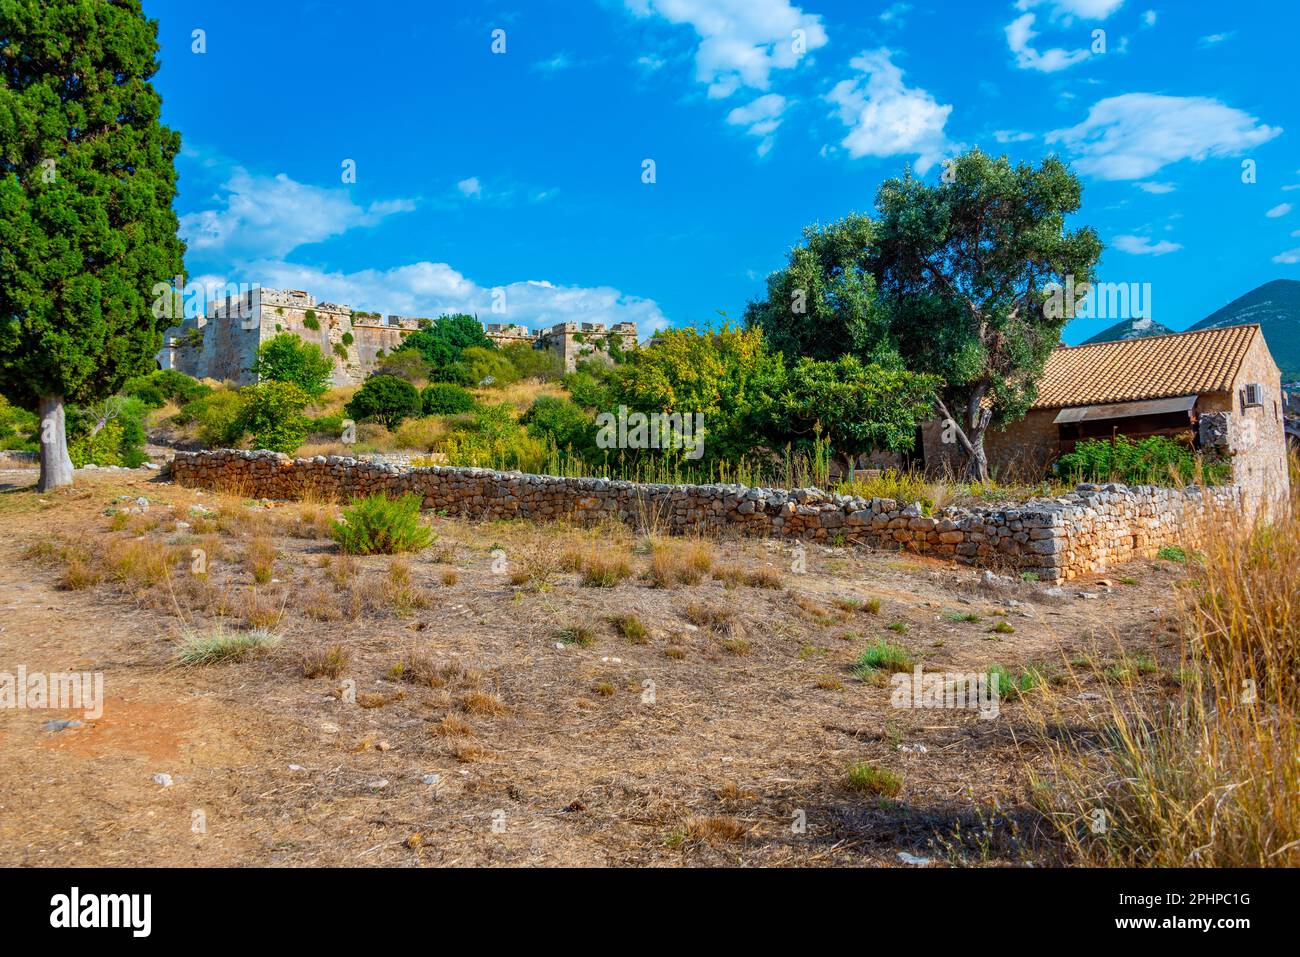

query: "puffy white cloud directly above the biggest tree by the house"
xmin=826 ymin=48 xmax=954 ymax=173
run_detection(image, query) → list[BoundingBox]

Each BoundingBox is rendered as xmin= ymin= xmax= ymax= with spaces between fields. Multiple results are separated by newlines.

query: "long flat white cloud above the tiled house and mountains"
xmin=1047 ymin=94 xmax=1282 ymax=179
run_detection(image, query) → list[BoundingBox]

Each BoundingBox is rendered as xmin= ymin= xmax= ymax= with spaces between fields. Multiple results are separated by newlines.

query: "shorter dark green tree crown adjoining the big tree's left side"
xmin=745 ymin=213 xmax=897 ymax=365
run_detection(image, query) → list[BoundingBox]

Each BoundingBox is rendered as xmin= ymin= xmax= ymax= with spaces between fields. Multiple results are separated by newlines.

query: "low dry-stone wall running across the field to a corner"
xmin=172 ymin=450 xmax=1239 ymax=583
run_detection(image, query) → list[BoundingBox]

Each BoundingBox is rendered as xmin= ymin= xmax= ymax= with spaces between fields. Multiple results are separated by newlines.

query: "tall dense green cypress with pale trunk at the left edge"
xmin=0 ymin=0 xmax=185 ymax=490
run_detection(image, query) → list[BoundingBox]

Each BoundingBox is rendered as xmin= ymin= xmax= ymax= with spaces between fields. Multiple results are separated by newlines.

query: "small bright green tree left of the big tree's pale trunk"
xmin=777 ymin=355 xmax=940 ymax=480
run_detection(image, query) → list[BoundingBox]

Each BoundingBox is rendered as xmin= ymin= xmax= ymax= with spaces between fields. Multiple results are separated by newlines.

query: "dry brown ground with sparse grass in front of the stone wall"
xmin=0 ymin=471 xmax=1178 ymax=866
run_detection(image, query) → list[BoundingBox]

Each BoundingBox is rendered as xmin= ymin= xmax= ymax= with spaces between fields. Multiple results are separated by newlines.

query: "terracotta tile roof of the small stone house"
xmin=1034 ymin=325 xmax=1260 ymax=408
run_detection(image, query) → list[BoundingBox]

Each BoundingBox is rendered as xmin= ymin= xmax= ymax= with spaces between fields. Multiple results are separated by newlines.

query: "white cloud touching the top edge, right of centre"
xmin=624 ymin=0 xmax=827 ymax=99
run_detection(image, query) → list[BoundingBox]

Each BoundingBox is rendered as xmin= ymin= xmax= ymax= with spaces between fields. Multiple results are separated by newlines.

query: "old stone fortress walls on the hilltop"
xmin=157 ymin=287 xmax=637 ymax=386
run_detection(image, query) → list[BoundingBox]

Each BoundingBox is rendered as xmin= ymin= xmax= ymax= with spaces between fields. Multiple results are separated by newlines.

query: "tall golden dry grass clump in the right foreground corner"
xmin=1036 ymin=486 xmax=1300 ymax=867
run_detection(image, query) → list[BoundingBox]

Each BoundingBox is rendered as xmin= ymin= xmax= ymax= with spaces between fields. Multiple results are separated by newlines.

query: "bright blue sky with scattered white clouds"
xmin=144 ymin=0 xmax=1300 ymax=343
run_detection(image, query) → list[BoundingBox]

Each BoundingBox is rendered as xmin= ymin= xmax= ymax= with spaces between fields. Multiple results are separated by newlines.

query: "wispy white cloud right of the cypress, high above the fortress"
xmin=181 ymin=166 xmax=416 ymax=257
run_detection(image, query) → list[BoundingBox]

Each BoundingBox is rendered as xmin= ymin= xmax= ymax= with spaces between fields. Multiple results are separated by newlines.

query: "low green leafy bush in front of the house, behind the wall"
xmin=1056 ymin=436 xmax=1231 ymax=485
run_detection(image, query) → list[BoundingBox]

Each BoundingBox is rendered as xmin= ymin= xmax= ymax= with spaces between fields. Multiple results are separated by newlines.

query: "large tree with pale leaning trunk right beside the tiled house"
xmin=872 ymin=150 xmax=1101 ymax=481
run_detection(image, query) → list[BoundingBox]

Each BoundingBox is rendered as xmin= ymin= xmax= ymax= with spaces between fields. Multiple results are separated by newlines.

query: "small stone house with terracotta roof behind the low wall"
xmin=922 ymin=325 xmax=1290 ymax=509
